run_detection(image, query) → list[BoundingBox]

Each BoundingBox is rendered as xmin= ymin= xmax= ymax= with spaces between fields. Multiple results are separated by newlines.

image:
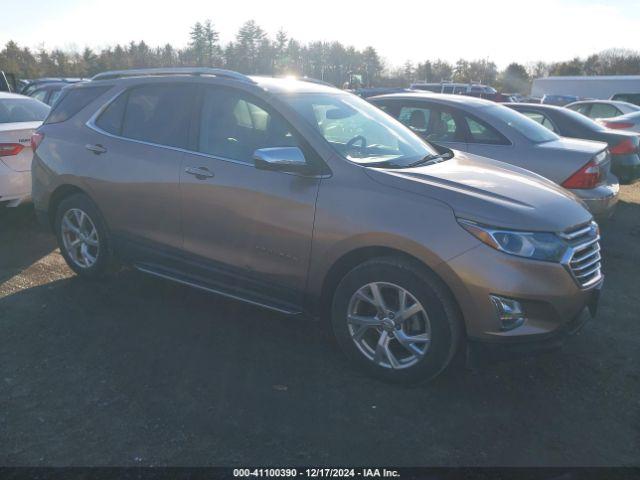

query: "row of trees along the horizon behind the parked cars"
xmin=0 ymin=20 xmax=640 ymax=93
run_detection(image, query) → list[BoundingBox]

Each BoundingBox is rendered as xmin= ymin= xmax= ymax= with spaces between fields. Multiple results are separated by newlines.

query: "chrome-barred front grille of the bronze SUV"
xmin=561 ymin=222 xmax=602 ymax=288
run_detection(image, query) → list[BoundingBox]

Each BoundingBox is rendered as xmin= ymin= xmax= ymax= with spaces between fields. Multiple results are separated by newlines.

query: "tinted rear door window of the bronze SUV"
xmin=119 ymin=85 xmax=194 ymax=148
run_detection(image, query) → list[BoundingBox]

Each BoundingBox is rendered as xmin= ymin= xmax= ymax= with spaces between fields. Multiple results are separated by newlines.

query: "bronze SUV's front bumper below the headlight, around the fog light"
xmin=437 ymin=244 xmax=603 ymax=345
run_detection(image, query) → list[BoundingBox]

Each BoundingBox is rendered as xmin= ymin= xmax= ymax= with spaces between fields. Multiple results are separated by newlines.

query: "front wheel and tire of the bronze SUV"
xmin=331 ymin=257 xmax=462 ymax=384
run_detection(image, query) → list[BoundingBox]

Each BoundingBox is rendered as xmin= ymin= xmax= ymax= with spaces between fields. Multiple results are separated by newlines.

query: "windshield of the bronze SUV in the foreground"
xmin=284 ymin=93 xmax=438 ymax=168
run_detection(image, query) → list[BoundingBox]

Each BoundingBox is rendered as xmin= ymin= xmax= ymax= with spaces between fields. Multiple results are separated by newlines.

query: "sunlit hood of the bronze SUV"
xmin=365 ymin=151 xmax=591 ymax=232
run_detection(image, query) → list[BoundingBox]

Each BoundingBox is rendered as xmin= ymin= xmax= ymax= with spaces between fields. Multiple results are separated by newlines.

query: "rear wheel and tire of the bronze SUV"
xmin=54 ymin=194 xmax=112 ymax=278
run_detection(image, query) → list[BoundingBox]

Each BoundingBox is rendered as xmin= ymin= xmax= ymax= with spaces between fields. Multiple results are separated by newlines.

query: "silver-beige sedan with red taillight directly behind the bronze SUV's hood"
xmin=369 ymin=93 xmax=619 ymax=219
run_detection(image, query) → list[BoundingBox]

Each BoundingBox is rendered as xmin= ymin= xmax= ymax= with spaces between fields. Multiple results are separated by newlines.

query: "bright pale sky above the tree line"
xmin=0 ymin=0 xmax=640 ymax=68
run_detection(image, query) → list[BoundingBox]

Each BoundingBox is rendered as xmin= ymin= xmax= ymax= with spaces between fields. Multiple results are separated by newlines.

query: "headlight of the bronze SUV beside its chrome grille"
xmin=458 ymin=219 xmax=569 ymax=262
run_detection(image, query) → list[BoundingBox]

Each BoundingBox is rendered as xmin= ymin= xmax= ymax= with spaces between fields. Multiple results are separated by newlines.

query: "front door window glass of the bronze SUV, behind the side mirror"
xmin=198 ymin=88 xmax=300 ymax=164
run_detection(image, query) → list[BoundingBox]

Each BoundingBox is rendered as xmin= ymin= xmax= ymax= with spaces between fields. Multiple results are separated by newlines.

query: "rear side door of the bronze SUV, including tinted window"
xmin=86 ymin=82 xmax=194 ymax=251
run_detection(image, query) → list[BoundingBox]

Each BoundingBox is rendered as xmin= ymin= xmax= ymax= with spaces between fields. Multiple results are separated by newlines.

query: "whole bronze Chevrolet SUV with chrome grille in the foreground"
xmin=33 ymin=68 xmax=603 ymax=382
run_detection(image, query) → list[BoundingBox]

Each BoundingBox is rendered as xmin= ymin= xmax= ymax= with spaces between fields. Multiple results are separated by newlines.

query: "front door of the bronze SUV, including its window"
xmin=180 ymin=86 xmax=320 ymax=305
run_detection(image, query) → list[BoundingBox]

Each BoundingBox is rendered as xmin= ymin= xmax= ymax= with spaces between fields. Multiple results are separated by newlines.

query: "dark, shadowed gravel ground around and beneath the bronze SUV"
xmin=0 ymin=185 xmax=640 ymax=466
